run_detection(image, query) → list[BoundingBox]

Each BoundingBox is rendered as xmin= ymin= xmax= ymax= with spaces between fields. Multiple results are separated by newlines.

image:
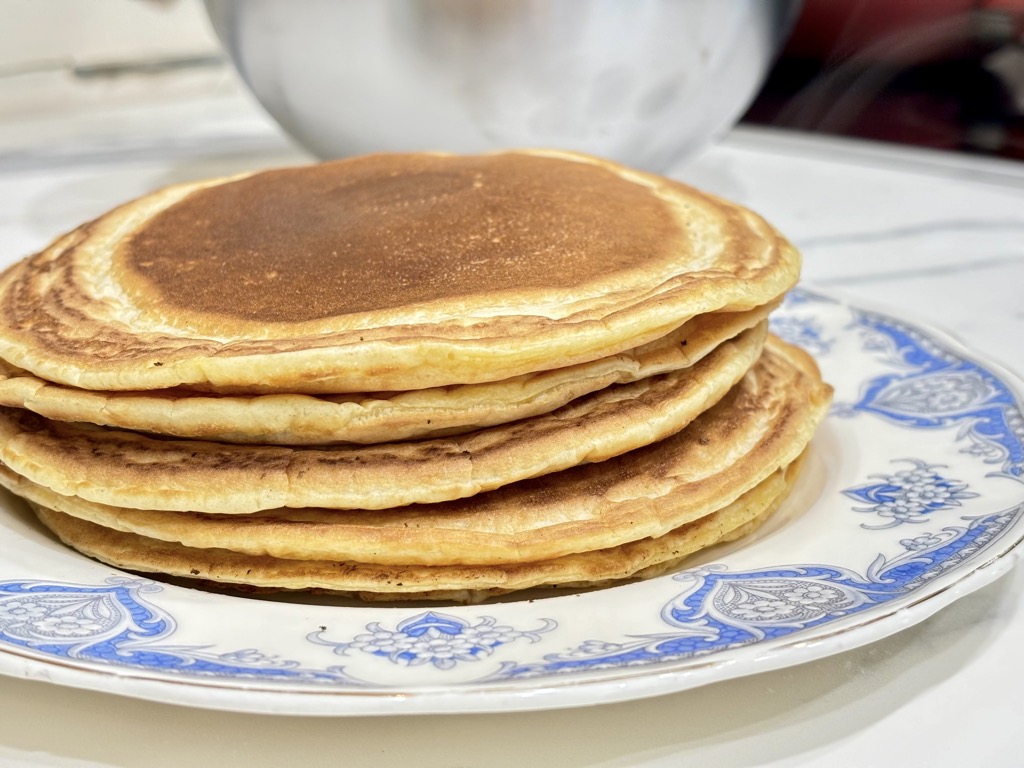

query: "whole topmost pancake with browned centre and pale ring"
xmin=0 ymin=152 xmax=800 ymax=394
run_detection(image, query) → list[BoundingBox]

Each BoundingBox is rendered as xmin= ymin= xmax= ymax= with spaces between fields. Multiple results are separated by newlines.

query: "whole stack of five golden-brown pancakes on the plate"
xmin=0 ymin=152 xmax=830 ymax=601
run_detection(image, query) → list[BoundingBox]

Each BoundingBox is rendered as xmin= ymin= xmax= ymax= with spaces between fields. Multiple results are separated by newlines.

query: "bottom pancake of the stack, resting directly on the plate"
xmin=31 ymin=454 xmax=796 ymax=602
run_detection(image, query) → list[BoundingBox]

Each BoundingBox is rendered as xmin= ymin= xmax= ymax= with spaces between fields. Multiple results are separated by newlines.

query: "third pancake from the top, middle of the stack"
xmin=0 ymin=326 xmax=770 ymax=514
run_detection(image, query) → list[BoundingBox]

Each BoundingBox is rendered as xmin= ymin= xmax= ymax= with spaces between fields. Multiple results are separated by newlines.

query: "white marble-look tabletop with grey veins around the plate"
xmin=0 ymin=79 xmax=1024 ymax=768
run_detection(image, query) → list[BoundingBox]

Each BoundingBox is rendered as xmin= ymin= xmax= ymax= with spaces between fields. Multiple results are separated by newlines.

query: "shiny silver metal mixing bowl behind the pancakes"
xmin=206 ymin=0 xmax=800 ymax=171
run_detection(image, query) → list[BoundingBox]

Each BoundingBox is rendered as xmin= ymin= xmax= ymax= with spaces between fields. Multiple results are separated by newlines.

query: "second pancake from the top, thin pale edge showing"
xmin=0 ymin=304 xmax=773 ymax=445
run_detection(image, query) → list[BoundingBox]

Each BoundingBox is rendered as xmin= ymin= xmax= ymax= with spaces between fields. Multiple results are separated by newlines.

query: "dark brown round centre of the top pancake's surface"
xmin=115 ymin=155 xmax=683 ymax=323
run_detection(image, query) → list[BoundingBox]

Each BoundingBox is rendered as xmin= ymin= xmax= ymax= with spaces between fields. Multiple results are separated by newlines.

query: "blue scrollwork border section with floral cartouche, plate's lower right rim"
xmin=493 ymin=512 xmax=1024 ymax=679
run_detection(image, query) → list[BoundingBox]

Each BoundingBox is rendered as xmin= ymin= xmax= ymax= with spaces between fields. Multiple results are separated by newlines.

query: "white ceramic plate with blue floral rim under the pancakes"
xmin=0 ymin=289 xmax=1024 ymax=715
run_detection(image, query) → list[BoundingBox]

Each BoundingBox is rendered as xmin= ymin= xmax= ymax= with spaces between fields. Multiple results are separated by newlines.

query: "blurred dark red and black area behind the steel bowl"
xmin=744 ymin=0 xmax=1024 ymax=160
